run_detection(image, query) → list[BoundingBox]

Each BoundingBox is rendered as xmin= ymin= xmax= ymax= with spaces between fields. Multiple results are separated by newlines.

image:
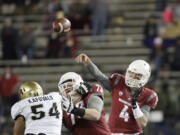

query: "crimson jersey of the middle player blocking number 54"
xmin=63 ymin=84 xmax=111 ymax=135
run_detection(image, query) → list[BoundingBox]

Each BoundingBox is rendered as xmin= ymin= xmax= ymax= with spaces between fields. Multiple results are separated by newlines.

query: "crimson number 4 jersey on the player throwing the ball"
xmin=109 ymin=74 xmax=158 ymax=134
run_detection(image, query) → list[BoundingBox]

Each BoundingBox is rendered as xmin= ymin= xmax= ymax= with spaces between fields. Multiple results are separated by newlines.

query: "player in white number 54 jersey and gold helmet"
xmin=11 ymin=81 xmax=62 ymax=135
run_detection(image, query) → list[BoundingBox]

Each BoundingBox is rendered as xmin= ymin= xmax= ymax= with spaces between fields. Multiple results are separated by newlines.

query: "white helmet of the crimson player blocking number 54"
xmin=58 ymin=72 xmax=84 ymax=96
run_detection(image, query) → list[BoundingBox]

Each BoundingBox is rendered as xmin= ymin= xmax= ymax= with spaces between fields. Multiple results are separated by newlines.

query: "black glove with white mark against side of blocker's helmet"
xmin=77 ymin=82 xmax=91 ymax=98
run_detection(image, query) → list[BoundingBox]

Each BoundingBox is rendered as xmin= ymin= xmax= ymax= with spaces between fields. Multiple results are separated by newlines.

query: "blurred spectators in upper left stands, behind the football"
xmin=1 ymin=0 xmax=109 ymax=60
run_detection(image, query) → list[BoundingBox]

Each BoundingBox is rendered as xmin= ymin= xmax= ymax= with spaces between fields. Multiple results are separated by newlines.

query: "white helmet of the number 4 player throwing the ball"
xmin=125 ymin=60 xmax=151 ymax=88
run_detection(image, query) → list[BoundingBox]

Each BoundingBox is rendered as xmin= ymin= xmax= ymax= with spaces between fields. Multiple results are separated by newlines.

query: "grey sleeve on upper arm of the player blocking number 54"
xmin=87 ymin=94 xmax=104 ymax=113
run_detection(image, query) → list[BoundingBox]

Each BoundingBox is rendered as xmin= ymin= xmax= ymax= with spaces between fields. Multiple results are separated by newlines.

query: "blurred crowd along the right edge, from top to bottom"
xmin=143 ymin=0 xmax=180 ymax=135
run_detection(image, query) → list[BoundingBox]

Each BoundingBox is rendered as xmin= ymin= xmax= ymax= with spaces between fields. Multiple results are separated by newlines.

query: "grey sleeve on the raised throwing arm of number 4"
xmin=87 ymin=62 xmax=113 ymax=92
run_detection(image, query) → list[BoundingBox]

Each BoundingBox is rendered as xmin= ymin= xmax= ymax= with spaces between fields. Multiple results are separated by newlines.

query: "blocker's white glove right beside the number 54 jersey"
xmin=62 ymin=96 xmax=74 ymax=113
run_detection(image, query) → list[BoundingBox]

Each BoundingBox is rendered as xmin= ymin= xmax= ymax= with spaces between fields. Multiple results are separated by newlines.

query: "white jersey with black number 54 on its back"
xmin=11 ymin=92 xmax=62 ymax=135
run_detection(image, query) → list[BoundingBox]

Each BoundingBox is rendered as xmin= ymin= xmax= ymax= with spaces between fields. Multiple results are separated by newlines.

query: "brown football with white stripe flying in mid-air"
xmin=53 ymin=18 xmax=71 ymax=33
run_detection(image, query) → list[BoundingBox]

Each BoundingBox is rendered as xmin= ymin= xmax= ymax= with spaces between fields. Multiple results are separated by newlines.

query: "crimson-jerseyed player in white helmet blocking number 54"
xmin=58 ymin=72 xmax=111 ymax=135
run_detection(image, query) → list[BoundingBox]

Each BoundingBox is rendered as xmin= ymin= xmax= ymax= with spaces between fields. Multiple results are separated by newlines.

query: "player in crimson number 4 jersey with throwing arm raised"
xmin=75 ymin=54 xmax=158 ymax=135
